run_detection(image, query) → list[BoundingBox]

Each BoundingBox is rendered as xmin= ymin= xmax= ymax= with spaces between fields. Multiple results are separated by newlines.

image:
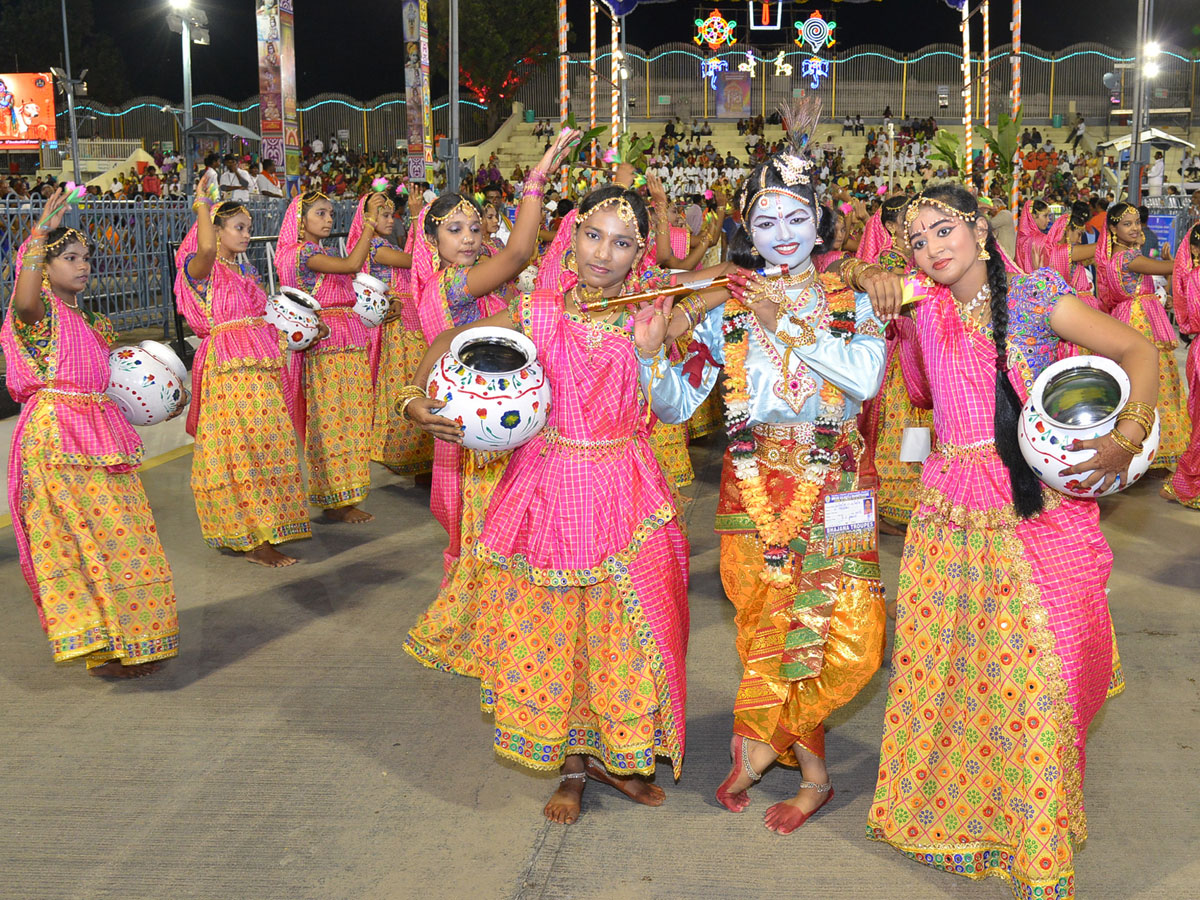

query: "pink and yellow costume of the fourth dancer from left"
xmin=346 ymin=197 xmax=433 ymax=475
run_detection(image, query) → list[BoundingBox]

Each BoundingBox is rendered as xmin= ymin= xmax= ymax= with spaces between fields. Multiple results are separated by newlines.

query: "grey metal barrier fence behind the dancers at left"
xmin=0 ymin=194 xmax=355 ymax=336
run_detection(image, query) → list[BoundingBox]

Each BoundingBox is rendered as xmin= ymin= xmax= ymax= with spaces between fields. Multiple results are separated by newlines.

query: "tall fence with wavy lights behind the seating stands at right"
xmin=517 ymin=43 xmax=1200 ymax=127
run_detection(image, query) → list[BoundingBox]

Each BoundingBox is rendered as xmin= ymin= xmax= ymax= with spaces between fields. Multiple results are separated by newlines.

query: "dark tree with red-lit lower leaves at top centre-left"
xmin=430 ymin=0 xmax=558 ymax=131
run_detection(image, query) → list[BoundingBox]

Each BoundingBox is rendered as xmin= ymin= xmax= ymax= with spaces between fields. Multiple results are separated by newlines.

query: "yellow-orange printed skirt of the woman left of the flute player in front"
xmin=475 ymin=520 xmax=688 ymax=779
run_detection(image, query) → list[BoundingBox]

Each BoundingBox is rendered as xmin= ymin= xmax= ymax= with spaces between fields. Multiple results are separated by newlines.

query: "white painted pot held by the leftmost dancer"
xmin=104 ymin=341 xmax=191 ymax=426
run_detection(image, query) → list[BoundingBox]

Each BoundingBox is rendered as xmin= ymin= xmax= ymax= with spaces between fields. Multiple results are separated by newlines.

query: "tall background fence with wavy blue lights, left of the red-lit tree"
xmin=55 ymin=94 xmax=488 ymax=158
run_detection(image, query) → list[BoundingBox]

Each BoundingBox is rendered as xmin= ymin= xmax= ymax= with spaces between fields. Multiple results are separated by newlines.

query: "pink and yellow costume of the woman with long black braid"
xmin=868 ymin=269 xmax=1123 ymax=900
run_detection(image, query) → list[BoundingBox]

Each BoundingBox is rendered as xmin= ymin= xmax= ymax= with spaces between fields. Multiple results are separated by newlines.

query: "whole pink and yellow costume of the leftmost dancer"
xmin=0 ymin=240 xmax=182 ymax=668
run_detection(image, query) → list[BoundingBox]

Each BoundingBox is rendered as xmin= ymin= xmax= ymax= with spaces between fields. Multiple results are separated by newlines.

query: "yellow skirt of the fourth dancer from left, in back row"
xmin=371 ymin=319 xmax=433 ymax=475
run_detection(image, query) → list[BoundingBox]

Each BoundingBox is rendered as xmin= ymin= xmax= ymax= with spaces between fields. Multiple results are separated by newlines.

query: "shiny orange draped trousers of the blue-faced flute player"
xmin=721 ymin=534 xmax=886 ymax=766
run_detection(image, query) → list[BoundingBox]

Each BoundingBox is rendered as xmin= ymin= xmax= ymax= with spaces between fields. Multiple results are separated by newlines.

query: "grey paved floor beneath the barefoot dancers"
xmin=0 ymin=444 xmax=1200 ymax=900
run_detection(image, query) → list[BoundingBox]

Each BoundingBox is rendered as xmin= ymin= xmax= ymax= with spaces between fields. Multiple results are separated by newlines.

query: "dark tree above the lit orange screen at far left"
xmin=0 ymin=0 xmax=130 ymax=103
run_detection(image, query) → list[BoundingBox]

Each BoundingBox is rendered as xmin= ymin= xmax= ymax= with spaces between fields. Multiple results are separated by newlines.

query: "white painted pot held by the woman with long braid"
xmin=1016 ymin=356 xmax=1159 ymax=498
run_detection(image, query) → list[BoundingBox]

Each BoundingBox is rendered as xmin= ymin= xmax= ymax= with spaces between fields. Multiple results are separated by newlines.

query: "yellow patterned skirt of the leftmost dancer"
xmin=17 ymin=403 xmax=179 ymax=668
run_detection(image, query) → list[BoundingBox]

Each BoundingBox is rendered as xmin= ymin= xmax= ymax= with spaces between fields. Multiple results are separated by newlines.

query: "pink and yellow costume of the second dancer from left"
xmin=175 ymin=226 xmax=312 ymax=552
